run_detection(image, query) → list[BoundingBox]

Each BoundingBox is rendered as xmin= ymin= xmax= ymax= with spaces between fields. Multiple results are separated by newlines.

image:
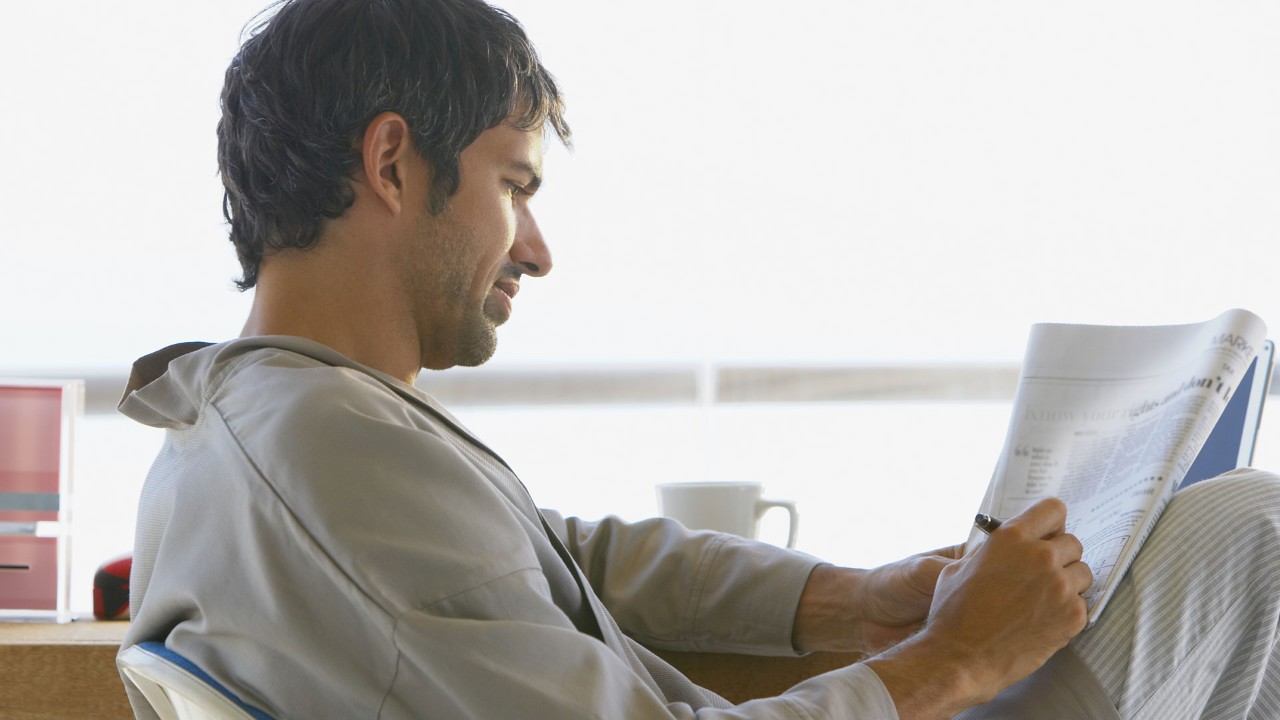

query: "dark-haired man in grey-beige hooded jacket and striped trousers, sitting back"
xmin=122 ymin=0 xmax=1280 ymax=719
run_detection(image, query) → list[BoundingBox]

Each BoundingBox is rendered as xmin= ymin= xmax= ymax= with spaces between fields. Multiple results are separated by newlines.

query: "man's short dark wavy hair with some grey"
xmin=218 ymin=0 xmax=571 ymax=290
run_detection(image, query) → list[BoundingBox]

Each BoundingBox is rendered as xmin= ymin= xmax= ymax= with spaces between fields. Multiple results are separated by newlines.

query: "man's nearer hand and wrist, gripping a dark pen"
xmin=867 ymin=500 xmax=1093 ymax=720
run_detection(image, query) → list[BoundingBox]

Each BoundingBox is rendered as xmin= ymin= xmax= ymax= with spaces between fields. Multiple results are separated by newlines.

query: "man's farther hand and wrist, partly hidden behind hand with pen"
xmin=792 ymin=546 xmax=964 ymax=653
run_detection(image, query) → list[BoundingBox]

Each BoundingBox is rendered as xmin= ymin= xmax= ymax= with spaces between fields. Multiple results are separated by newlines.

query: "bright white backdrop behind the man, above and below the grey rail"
xmin=0 ymin=0 xmax=1280 ymax=605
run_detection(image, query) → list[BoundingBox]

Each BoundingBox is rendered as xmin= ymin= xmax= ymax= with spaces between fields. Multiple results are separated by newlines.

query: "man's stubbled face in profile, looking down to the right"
xmin=402 ymin=123 xmax=552 ymax=369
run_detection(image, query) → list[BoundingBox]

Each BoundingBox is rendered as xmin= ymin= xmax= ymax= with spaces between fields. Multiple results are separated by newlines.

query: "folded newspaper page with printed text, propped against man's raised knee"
xmin=970 ymin=310 xmax=1266 ymax=625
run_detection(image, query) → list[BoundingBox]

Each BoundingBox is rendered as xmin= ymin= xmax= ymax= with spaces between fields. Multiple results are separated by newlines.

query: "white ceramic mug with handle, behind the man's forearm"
xmin=658 ymin=483 xmax=800 ymax=548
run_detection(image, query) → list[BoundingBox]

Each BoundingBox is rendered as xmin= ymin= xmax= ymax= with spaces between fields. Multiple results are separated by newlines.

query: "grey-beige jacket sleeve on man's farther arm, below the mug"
xmin=544 ymin=511 xmax=818 ymax=655
